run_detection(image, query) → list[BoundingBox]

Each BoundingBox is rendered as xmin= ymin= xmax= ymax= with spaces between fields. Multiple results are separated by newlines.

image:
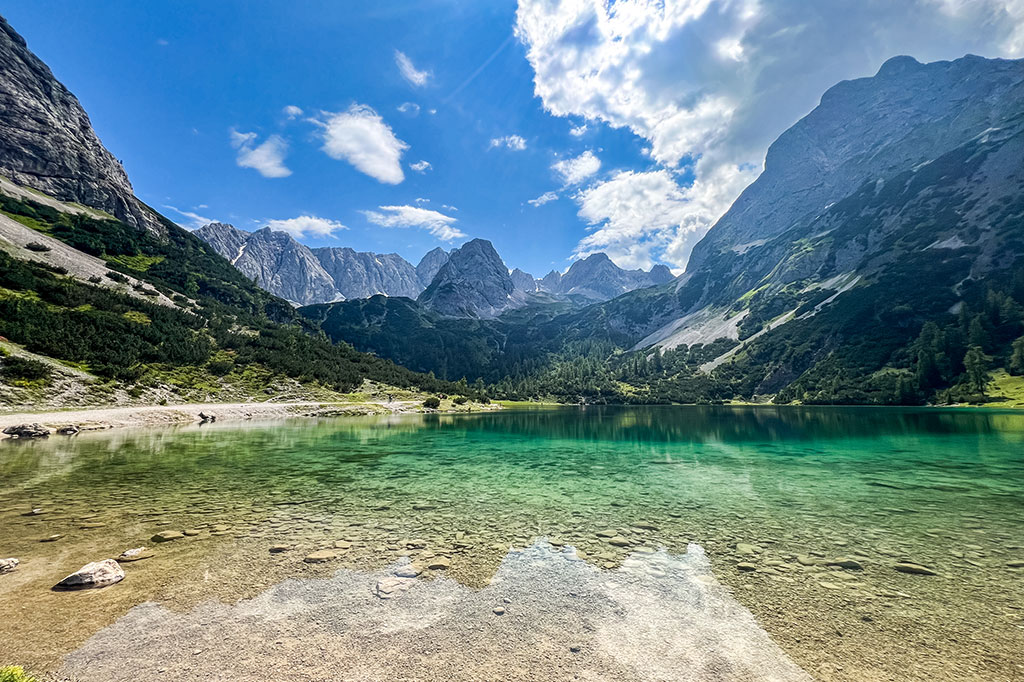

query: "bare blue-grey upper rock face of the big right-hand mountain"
xmin=687 ymin=55 xmax=1024 ymax=271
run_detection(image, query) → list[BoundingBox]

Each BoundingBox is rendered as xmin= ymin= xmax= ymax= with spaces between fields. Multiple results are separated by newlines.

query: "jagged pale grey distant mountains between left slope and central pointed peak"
xmin=195 ymin=222 xmax=432 ymax=305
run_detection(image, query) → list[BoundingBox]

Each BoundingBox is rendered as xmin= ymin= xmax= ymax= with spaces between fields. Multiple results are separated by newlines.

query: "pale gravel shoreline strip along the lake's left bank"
xmin=0 ymin=400 xmax=436 ymax=437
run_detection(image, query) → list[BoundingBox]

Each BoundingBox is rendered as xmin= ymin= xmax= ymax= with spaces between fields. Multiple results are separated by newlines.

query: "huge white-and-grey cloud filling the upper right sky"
xmin=515 ymin=0 xmax=1024 ymax=265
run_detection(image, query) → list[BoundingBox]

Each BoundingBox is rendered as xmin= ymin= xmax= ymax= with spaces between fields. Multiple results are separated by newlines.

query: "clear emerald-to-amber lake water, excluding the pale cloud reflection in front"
xmin=0 ymin=408 xmax=1024 ymax=679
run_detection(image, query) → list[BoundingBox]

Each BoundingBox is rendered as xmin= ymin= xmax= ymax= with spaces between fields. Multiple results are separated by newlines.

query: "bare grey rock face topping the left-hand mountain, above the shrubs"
xmin=0 ymin=17 xmax=165 ymax=233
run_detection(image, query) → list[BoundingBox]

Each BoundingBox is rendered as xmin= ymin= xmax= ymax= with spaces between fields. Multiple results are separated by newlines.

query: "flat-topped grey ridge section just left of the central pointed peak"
xmin=312 ymin=247 xmax=421 ymax=299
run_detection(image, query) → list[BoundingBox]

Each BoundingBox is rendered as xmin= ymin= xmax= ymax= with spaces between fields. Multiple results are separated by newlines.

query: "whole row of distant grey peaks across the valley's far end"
xmin=195 ymin=222 xmax=673 ymax=317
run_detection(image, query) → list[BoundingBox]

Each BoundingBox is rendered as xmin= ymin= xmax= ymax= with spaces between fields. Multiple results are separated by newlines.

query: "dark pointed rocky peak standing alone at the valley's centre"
xmin=418 ymin=240 xmax=525 ymax=318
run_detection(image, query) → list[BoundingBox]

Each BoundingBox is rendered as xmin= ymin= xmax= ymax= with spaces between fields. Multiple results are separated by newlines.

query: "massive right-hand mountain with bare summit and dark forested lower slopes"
xmin=307 ymin=55 xmax=1024 ymax=403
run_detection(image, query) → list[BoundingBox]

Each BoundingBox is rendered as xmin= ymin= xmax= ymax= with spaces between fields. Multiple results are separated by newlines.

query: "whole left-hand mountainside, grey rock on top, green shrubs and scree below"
xmin=0 ymin=15 xmax=467 ymax=410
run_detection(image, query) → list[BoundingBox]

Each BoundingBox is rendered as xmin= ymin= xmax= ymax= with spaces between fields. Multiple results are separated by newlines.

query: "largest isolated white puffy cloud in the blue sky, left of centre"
xmin=317 ymin=104 xmax=409 ymax=184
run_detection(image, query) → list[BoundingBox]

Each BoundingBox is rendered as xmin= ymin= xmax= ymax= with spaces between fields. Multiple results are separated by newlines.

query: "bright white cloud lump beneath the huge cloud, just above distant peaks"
xmin=575 ymin=166 xmax=756 ymax=268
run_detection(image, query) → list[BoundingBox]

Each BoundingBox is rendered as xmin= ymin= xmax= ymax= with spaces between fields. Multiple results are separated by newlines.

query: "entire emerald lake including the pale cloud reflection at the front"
xmin=0 ymin=407 xmax=1024 ymax=680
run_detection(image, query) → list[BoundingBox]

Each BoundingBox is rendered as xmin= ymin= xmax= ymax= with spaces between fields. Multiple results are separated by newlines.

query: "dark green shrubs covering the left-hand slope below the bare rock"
xmin=0 ymin=191 xmax=479 ymax=401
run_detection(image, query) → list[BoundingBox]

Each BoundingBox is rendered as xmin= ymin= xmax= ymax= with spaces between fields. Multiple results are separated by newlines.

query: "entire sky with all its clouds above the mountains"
xmin=3 ymin=0 xmax=1024 ymax=275
